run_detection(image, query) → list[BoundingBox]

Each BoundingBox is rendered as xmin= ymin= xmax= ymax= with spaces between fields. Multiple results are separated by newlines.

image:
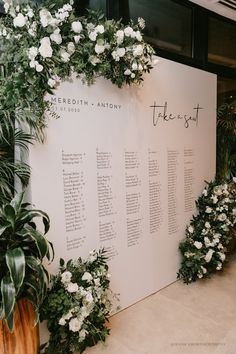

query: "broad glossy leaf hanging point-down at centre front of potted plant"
xmin=6 ymin=248 xmax=25 ymax=294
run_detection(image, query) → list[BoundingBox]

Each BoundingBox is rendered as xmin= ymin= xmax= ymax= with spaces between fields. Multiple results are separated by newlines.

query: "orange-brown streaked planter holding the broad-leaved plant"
xmin=0 ymin=300 xmax=39 ymax=354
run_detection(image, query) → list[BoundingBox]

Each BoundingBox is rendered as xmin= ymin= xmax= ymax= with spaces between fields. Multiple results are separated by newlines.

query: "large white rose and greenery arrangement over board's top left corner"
xmin=0 ymin=0 xmax=154 ymax=141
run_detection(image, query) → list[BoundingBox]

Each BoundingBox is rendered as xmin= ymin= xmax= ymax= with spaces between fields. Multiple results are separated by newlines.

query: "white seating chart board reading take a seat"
xmin=30 ymin=58 xmax=216 ymax=308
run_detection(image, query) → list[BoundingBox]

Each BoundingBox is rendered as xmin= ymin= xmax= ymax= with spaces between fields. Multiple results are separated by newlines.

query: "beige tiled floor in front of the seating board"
xmin=85 ymin=255 xmax=236 ymax=354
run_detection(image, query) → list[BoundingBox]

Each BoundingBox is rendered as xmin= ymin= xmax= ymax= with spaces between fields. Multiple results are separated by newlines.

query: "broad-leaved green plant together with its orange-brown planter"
xmin=0 ymin=193 xmax=53 ymax=354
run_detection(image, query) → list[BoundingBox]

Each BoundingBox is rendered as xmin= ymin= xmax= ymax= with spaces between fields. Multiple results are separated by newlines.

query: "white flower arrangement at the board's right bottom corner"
xmin=178 ymin=178 xmax=236 ymax=283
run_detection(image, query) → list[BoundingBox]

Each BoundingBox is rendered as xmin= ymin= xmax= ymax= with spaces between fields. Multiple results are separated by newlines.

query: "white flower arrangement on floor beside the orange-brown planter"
xmin=41 ymin=250 xmax=114 ymax=354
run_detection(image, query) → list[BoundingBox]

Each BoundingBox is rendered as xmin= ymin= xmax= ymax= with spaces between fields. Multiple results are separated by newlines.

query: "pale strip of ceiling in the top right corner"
xmin=189 ymin=0 xmax=236 ymax=21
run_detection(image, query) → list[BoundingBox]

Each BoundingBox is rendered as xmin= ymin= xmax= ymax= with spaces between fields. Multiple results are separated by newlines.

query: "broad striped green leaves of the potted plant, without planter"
xmin=0 ymin=193 xmax=53 ymax=331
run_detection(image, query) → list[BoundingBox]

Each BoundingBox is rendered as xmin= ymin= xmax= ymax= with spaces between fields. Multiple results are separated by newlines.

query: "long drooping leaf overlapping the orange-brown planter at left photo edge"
xmin=1 ymin=276 xmax=16 ymax=331
